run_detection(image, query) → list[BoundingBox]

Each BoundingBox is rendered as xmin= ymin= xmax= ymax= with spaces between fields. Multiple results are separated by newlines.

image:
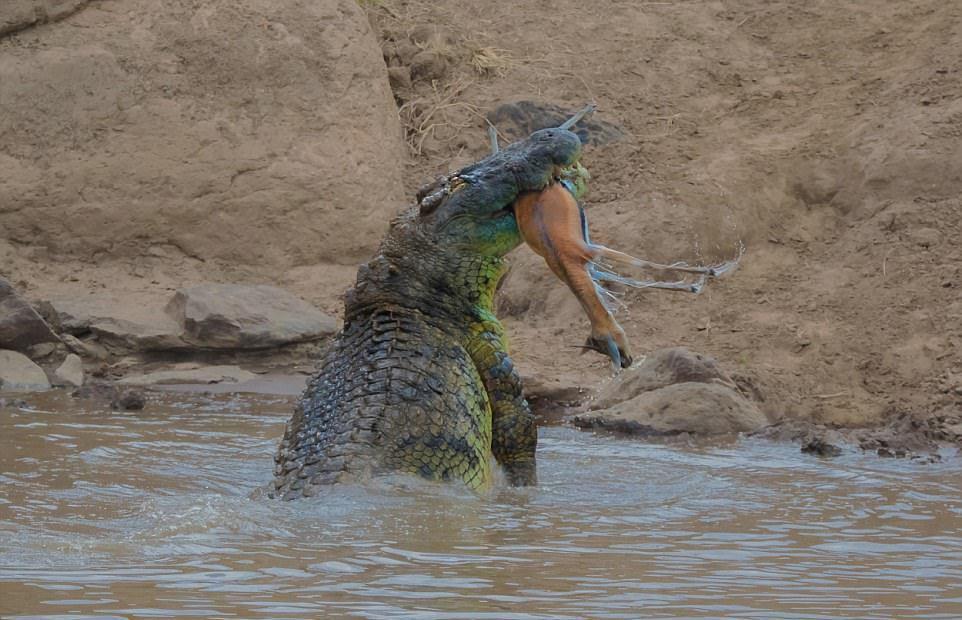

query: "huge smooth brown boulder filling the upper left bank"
xmin=0 ymin=0 xmax=406 ymax=273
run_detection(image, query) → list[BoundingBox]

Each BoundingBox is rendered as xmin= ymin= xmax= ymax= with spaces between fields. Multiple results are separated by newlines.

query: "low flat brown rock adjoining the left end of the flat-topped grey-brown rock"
xmin=49 ymin=295 xmax=189 ymax=357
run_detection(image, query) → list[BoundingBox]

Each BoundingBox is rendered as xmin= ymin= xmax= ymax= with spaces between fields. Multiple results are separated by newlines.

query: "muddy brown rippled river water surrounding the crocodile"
xmin=0 ymin=393 xmax=962 ymax=619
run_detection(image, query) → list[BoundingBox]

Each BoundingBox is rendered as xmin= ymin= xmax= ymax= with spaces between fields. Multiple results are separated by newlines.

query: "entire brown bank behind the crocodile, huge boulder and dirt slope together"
xmin=0 ymin=0 xmax=962 ymax=450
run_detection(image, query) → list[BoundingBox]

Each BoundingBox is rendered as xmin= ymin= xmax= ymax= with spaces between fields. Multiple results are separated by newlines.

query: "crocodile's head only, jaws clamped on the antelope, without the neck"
xmin=418 ymin=128 xmax=588 ymax=257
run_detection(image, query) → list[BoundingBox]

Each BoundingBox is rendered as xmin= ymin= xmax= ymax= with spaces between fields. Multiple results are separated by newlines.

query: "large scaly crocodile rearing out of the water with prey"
xmin=271 ymin=128 xmax=587 ymax=499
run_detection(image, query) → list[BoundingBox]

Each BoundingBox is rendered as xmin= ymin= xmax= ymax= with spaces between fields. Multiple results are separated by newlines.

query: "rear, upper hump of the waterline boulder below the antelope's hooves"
xmin=589 ymin=347 xmax=735 ymax=409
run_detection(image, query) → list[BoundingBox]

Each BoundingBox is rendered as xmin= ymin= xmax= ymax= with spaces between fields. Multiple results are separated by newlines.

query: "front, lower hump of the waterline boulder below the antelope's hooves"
xmin=573 ymin=382 xmax=768 ymax=436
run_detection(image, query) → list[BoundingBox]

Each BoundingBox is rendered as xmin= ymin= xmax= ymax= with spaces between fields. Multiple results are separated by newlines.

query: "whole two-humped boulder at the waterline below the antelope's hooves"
xmin=572 ymin=347 xmax=768 ymax=436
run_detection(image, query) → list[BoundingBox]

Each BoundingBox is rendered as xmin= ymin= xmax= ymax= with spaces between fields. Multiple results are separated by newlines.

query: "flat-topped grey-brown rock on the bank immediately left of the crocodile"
xmin=167 ymin=284 xmax=337 ymax=349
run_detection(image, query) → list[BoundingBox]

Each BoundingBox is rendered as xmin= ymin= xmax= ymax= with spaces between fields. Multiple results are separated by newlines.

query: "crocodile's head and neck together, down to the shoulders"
xmin=345 ymin=129 xmax=587 ymax=321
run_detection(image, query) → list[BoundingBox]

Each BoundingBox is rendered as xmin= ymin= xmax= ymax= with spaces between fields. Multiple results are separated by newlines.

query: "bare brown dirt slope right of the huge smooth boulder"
xmin=364 ymin=0 xmax=962 ymax=424
